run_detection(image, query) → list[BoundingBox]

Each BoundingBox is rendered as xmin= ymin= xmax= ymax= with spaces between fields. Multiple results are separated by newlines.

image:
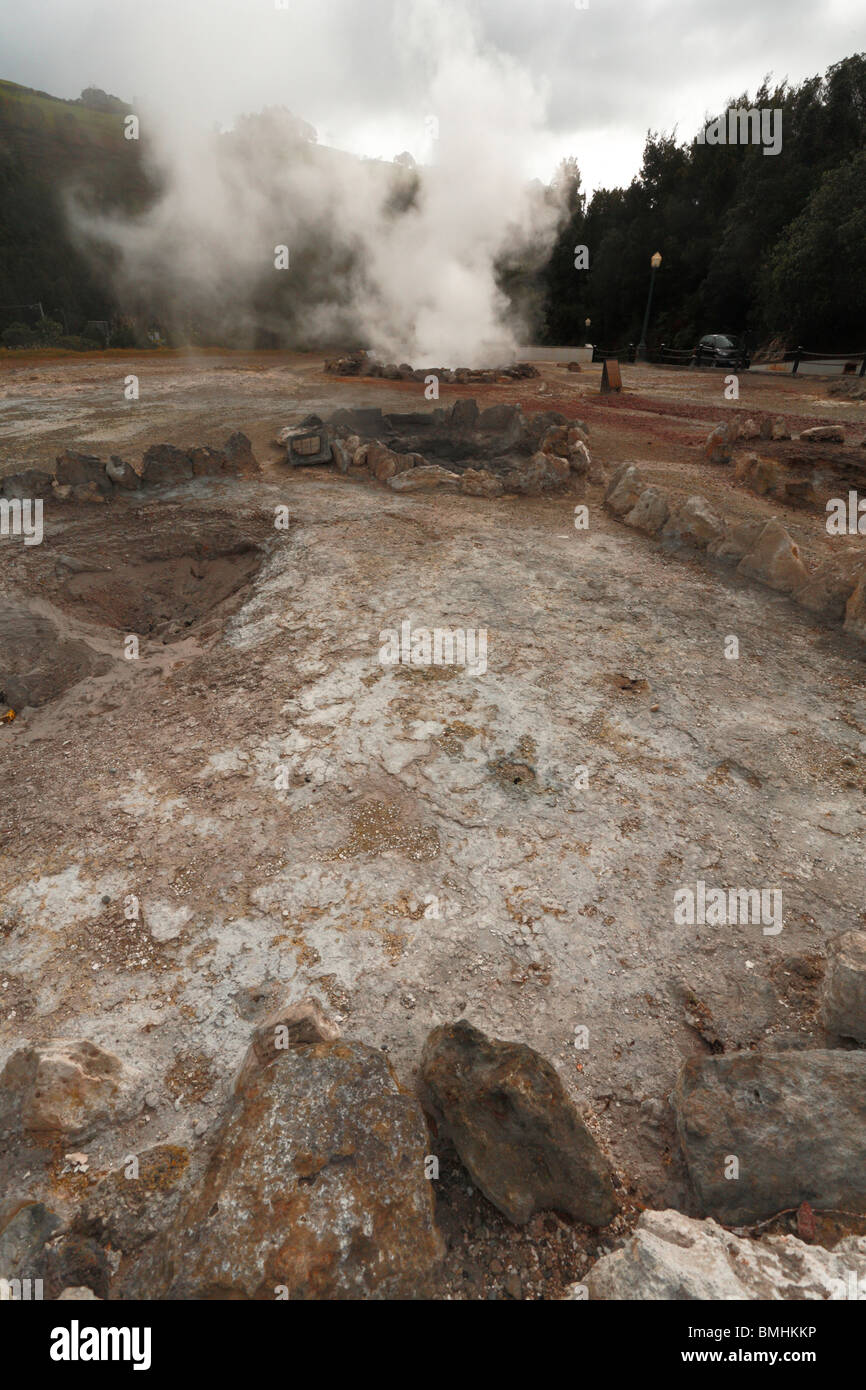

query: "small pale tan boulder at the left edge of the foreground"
xmin=0 ymin=1038 xmax=143 ymax=1143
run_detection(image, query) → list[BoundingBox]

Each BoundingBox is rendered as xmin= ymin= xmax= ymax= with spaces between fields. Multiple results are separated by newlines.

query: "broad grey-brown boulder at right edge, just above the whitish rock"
xmin=671 ymin=1051 xmax=866 ymax=1225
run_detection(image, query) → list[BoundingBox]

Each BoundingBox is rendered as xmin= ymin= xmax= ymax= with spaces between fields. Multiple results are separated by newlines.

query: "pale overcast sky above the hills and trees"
xmin=0 ymin=0 xmax=866 ymax=189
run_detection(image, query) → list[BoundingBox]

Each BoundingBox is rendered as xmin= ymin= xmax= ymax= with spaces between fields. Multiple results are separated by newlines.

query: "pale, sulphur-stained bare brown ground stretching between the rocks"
xmin=0 ymin=354 xmax=866 ymax=1297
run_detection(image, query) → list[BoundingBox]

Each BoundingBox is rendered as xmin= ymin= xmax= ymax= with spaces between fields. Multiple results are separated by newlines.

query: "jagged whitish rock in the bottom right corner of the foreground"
xmin=585 ymin=1211 xmax=866 ymax=1302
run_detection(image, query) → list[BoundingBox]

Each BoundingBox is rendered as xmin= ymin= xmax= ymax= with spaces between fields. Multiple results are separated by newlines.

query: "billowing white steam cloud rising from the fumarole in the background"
xmin=72 ymin=0 xmax=559 ymax=366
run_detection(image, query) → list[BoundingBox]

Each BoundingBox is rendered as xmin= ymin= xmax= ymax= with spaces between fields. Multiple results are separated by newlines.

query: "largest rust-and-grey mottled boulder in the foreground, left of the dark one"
xmin=160 ymin=1041 xmax=442 ymax=1300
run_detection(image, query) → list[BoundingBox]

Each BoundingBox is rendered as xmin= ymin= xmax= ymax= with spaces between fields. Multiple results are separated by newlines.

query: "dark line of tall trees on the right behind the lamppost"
xmin=539 ymin=54 xmax=866 ymax=352
